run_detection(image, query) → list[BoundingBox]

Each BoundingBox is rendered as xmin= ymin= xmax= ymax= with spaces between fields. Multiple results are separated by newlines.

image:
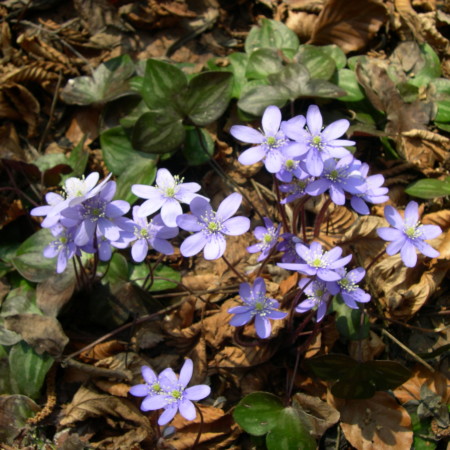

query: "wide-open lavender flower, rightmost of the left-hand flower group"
xmin=177 ymin=192 xmax=250 ymax=260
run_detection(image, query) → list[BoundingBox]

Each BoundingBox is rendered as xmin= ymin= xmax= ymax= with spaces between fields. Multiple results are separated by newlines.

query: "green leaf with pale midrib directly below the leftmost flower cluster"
xmin=12 ymin=228 xmax=55 ymax=283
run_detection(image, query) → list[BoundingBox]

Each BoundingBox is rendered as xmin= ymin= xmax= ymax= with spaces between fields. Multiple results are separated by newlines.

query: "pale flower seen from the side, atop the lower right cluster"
xmin=278 ymin=242 xmax=352 ymax=281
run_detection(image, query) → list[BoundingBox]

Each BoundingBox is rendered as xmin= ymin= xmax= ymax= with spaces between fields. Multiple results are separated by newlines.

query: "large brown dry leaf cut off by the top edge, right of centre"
xmin=308 ymin=0 xmax=387 ymax=53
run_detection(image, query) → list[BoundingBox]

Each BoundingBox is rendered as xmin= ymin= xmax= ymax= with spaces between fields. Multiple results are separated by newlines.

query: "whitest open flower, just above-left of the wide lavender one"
xmin=131 ymin=169 xmax=204 ymax=227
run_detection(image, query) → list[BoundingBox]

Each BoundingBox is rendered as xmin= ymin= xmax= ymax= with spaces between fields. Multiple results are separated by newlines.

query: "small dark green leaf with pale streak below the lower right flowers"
xmin=333 ymin=295 xmax=370 ymax=341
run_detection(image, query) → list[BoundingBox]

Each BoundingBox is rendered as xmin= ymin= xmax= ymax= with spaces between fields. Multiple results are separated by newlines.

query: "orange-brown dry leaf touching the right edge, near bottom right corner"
xmin=394 ymin=365 xmax=450 ymax=404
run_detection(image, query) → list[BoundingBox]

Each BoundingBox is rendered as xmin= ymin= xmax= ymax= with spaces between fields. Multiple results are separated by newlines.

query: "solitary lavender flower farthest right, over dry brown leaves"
xmin=377 ymin=202 xmax=442 ymax=267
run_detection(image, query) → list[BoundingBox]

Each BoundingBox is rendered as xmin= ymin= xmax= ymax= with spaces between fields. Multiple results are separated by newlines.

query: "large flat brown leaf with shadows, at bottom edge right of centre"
xmin=328 ymin=392 xmax=413 ymax=450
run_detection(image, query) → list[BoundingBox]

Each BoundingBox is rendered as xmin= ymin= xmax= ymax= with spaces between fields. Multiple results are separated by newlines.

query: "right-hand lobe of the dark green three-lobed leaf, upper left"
xmin=183 ymin=72 xmax=233 ymax=126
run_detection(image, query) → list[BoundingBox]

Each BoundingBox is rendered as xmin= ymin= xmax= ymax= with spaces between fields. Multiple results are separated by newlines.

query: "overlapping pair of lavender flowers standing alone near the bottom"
xmin=129 ymin=359 xmax=211 ymax=426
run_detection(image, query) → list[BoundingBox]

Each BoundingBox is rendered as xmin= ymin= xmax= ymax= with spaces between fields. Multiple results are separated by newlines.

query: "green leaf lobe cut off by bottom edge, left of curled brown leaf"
xmin=266 ymin=406 xmax=317 ymax=450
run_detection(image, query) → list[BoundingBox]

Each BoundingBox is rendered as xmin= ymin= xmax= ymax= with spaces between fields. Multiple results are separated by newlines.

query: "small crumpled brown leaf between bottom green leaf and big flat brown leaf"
xmin=292 ymin=392 xmax=340 ymax=438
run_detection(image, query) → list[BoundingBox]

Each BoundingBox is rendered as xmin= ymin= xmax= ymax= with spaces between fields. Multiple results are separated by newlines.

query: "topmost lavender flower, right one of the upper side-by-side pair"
xmin=283 ymin=105 xmax=355 ymax=177
